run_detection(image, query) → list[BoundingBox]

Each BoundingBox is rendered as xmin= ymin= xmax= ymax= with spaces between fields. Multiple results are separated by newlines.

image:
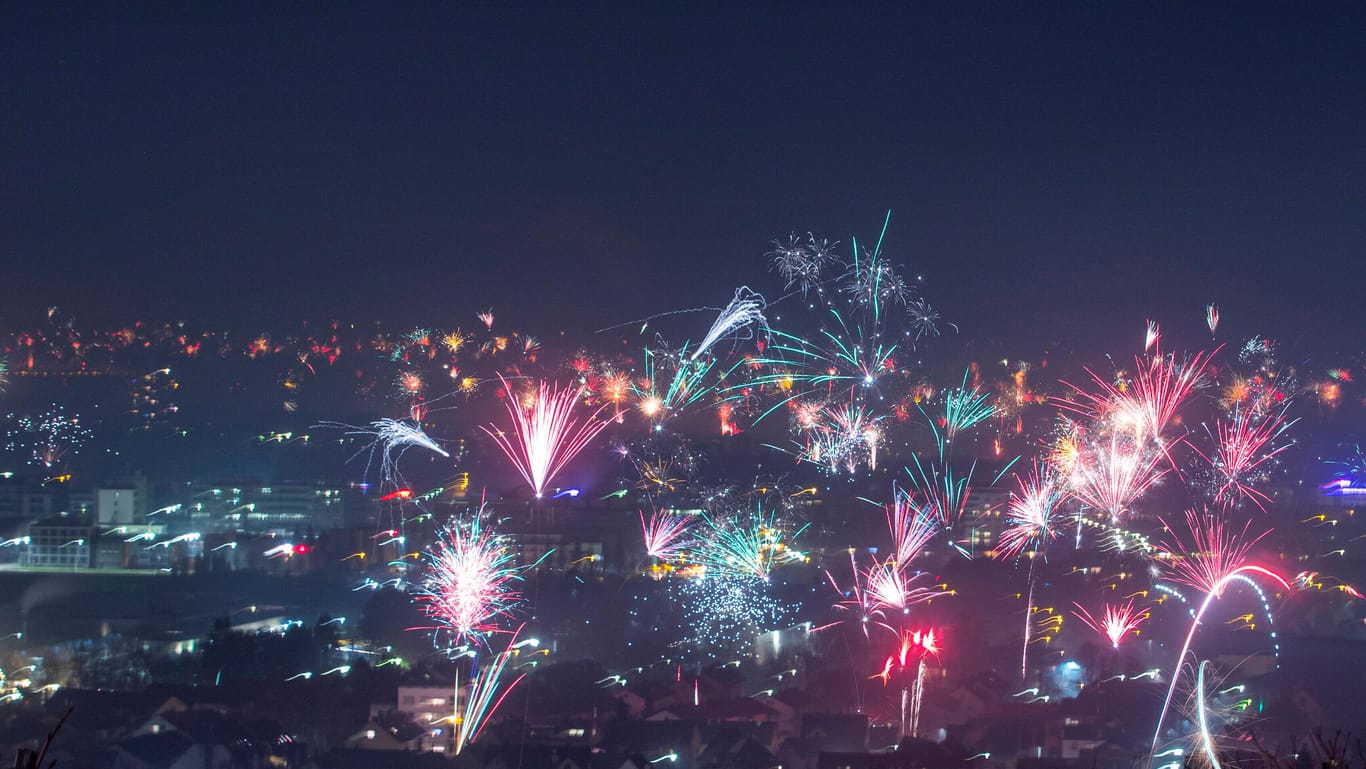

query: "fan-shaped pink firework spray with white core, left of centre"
xmin=479 ymin=376 xmax=608 ymax=499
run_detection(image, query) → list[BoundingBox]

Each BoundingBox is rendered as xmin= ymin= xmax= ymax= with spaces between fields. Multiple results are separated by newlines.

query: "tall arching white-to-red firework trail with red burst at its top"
xmin=1149 ymin=509 xmax=1291 ymax=754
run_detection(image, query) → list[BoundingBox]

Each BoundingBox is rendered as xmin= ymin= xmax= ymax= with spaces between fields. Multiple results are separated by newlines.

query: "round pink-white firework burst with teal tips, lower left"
xmin=417 ymin=511 xmax=527 ymax=646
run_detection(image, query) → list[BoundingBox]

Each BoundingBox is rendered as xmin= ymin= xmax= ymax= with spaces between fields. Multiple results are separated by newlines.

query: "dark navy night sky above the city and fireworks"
xmin=0 ymin=3 xmax=1366 ymax=347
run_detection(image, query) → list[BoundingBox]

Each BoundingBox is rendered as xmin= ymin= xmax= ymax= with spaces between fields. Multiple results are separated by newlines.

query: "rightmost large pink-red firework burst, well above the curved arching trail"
xmin=1197 ymin=408 xmax=1299 ymax=512
